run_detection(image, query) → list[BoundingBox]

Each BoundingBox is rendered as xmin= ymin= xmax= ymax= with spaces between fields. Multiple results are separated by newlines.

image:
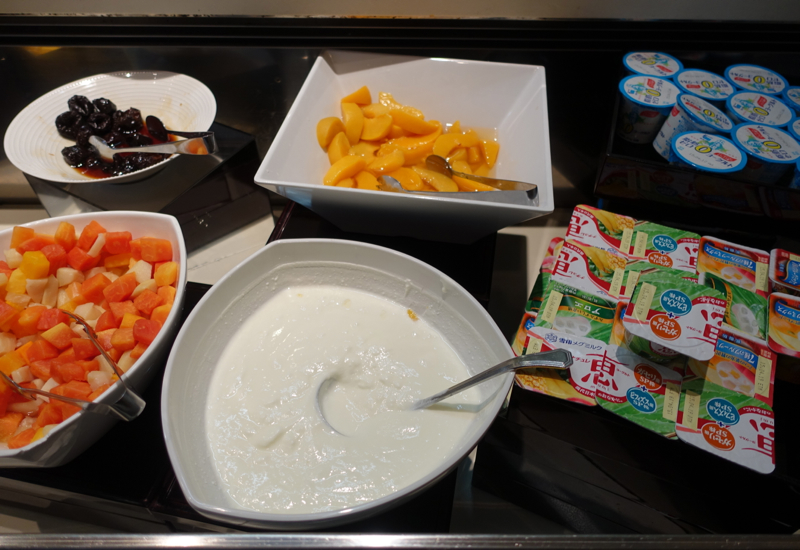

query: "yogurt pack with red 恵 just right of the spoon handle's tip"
xmin=595 ymin=346 xmax=681 ymax=438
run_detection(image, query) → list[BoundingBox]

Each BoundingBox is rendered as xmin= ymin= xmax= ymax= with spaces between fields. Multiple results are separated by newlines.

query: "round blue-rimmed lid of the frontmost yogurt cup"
xmin=672 ymin=132 xmax=747 ymax=174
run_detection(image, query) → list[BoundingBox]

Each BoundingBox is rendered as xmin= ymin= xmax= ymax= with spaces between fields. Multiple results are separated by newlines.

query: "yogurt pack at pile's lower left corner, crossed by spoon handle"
xmin=515 ymin=327 xmax=605 ymax=406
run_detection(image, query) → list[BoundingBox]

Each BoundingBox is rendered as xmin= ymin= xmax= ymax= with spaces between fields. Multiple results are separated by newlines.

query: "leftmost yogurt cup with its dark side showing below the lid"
xmin=617 ymin=75 xmax=680 ymax=143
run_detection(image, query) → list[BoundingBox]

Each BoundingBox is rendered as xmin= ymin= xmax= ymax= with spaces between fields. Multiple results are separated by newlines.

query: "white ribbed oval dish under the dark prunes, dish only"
xmin=3 ymin=71 xmax=217 ymax=183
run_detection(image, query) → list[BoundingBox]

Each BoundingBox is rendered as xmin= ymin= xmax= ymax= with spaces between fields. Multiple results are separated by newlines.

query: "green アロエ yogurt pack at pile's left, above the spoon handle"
xmin=534 ymin=281 xmax=617 ymax=343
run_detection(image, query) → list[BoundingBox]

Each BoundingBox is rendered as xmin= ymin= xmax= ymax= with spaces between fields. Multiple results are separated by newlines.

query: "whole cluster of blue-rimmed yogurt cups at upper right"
xmin=617 ymin=52 xmax=800 ymax=189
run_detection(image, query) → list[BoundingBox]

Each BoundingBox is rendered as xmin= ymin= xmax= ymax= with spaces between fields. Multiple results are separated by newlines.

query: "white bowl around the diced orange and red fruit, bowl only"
xmin=0 ymin=211 xmax=186 ymax=468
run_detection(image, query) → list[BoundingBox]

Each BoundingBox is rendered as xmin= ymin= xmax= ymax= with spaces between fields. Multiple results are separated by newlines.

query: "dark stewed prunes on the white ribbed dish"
xmin=56 ymin=95 xmax=169 ymax=178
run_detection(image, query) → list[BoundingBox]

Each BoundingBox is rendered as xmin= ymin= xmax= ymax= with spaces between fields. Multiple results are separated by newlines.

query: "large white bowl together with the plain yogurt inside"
xmin=161 ymin=239 xmax=513 ymax=530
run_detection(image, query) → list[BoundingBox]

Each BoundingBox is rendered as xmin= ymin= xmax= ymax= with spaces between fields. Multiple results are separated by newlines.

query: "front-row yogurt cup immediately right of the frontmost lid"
xmin=731 ymin=124 xmax=800 ymax=184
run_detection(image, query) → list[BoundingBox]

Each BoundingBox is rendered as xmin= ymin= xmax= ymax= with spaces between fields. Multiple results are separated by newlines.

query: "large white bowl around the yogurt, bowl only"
xmin=161 ymin=239 xmax=513 ymax=530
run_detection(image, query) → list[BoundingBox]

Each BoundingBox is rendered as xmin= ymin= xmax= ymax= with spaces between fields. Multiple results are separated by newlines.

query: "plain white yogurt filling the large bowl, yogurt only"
xmin=205 ymin=285 xmax=481 ymax=514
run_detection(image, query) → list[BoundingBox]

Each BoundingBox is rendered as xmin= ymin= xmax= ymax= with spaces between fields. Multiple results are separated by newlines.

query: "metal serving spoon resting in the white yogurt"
xmin=315 ymin=349 xmax=572 ymax=433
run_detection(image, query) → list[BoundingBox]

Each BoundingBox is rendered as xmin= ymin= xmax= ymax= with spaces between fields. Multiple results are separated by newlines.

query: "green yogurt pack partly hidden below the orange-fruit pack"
xmin=700 ymin=273 xmax=769 ymax=341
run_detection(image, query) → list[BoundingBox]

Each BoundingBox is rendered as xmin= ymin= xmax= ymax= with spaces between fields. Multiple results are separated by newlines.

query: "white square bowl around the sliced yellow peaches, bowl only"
xmin=255 ymin=52 xmax=553 ymax=243
